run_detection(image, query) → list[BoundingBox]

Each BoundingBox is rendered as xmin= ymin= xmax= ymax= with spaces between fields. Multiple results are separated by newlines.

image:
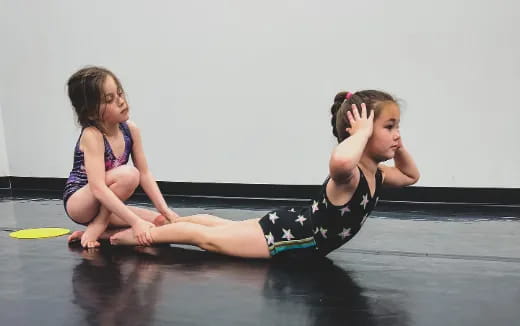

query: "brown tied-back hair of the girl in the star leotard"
xmin=330 ymin=90 xmax=397 ymax=143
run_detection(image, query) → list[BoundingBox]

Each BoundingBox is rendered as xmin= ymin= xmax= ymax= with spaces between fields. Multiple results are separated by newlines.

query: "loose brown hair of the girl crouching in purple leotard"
xmin=67 ymin=66 xmax=123 ymax=132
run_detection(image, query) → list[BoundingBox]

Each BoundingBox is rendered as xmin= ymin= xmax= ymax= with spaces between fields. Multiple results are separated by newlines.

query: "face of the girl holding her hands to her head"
xmin=365 ymin=103 xmax=401 ymax=162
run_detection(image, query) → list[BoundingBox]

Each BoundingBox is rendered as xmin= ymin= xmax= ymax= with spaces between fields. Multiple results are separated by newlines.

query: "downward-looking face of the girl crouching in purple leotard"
xmin=99 ymin=75 xmax=130 ymax=124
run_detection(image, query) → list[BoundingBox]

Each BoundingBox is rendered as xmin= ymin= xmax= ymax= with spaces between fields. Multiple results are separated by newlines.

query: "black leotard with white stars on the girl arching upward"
xmin=259 ymin=169 xmax=383 ymax=256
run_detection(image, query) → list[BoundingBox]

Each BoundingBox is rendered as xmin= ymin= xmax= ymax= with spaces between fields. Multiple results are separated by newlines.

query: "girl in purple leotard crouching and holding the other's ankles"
xmin=63 ymin=67 xmax=177 ymax=248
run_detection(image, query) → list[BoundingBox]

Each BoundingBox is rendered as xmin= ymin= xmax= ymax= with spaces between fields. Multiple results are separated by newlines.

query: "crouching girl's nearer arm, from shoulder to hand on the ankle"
xmin=80 ymin=127 xmax=151 ymax=244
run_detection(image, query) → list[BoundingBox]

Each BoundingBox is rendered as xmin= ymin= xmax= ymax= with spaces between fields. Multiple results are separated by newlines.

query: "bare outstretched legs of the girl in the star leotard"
xmin=110 ymin=215 xmax=271 ymax=258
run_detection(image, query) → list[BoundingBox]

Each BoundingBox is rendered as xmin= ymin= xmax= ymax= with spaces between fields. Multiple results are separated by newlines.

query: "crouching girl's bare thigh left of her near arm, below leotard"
xmin=65 ymin=184 xmax=101 ymax=224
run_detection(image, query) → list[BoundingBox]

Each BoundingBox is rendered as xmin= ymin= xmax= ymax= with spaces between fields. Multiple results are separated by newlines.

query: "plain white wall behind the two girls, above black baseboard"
xmin=0 ymin=0 xmax=520 ymax=187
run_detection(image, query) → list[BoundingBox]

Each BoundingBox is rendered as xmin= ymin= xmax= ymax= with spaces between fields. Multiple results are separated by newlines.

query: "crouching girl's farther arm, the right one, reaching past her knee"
xmin=127 ymin=121 xmax=178 ymax=222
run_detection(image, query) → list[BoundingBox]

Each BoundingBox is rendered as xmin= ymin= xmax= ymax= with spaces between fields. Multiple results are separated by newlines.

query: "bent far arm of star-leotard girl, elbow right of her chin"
xmin=379 ymin=145 xmax=420 ymax=187
